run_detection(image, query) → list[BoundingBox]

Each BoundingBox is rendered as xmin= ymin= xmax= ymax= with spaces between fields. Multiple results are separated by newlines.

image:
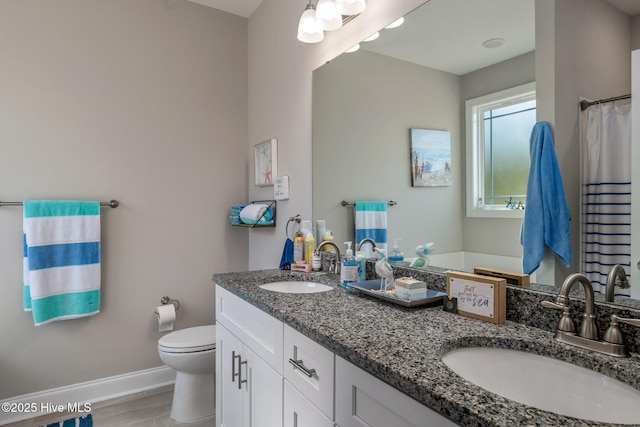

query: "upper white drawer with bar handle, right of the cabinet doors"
xmin=283 ymin=325 xmax=334 ymax=420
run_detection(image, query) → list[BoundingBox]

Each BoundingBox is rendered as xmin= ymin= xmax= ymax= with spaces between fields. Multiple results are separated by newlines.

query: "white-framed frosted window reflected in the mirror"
xmin=466 ymin=83 xmax=536 ymax=218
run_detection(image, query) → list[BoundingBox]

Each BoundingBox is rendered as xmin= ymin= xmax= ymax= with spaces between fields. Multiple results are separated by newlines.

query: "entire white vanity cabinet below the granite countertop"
xmin=216 ymin=286 xmax=455 ymax=427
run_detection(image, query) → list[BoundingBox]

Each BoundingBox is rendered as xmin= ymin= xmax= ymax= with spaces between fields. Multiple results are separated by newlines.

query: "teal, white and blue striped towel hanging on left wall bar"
xmin=23 ymin=200 xmax=100 ymax=326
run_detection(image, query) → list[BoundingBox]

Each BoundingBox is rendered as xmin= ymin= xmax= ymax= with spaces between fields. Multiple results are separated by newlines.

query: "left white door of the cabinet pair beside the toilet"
xmin=216 ymin=323 xmax=243 ymax=427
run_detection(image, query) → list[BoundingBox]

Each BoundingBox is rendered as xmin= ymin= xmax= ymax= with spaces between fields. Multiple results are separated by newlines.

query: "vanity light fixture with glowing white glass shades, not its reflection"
xmin=298 ymin=0 xmax=366 ymax=43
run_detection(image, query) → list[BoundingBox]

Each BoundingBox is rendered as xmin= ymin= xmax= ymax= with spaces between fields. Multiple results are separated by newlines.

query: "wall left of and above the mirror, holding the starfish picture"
xmin=247 ymin=0 xmax=424 ymax=270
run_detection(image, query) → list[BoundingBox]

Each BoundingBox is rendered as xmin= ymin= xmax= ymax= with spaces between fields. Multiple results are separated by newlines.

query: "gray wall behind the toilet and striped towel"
xmin=0 ymin=0 xmax=248 ymax=399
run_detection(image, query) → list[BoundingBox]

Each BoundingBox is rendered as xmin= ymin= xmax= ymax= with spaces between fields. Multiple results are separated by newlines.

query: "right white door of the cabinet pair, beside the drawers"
xmin=244 ymin=346 xmax=283 ymax=427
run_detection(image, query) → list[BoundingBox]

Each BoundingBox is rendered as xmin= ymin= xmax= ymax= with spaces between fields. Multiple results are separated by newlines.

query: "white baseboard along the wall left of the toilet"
xmin=0 ymin=366 xmax=176 ymax=425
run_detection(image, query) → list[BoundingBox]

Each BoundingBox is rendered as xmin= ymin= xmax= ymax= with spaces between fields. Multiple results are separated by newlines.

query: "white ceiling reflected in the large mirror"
xmin=360 ymin=0 xmax=535 ymax=75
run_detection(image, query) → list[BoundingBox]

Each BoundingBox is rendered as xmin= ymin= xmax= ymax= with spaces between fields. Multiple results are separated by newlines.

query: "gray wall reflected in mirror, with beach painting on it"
xmin=312 ymin=49 xmax=464 ymax=256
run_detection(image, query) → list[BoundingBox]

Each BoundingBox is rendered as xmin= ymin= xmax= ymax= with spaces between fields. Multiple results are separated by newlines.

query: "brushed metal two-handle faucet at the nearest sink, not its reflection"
xmin=540 ymin=273 xmax=640 ymax=357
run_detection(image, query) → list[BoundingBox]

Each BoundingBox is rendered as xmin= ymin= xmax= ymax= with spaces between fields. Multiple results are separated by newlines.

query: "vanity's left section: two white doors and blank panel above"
xmin=216 ymin=287 xmax=283 ymax=427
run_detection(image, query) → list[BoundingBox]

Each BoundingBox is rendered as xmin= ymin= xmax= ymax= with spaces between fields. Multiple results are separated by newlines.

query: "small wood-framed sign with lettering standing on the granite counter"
xmin=447 ymin=271 xmax=507 ymax=323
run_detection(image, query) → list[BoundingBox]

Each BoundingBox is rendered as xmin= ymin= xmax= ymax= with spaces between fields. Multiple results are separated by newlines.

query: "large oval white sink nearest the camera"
xmin=442 ymin=347 xmax=640 ymax=424
